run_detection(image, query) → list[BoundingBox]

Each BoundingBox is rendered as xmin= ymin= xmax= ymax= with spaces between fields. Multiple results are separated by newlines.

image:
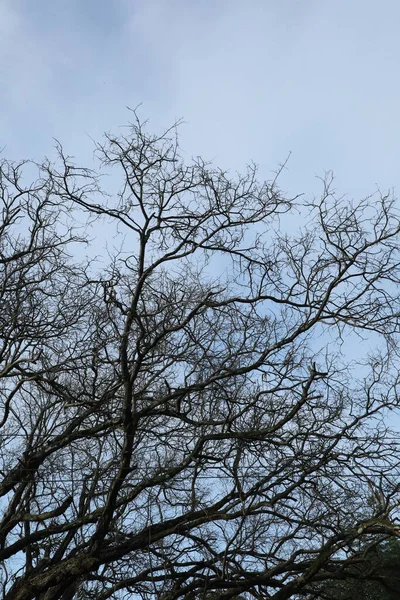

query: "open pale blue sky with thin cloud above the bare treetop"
xmin=0 ymin=0 xmax=400 ymax=202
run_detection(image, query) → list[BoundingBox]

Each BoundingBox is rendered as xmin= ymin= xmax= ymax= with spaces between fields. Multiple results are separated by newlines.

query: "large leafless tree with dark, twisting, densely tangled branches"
xmin=0 ymin=115 xmax=400 ymax=600
